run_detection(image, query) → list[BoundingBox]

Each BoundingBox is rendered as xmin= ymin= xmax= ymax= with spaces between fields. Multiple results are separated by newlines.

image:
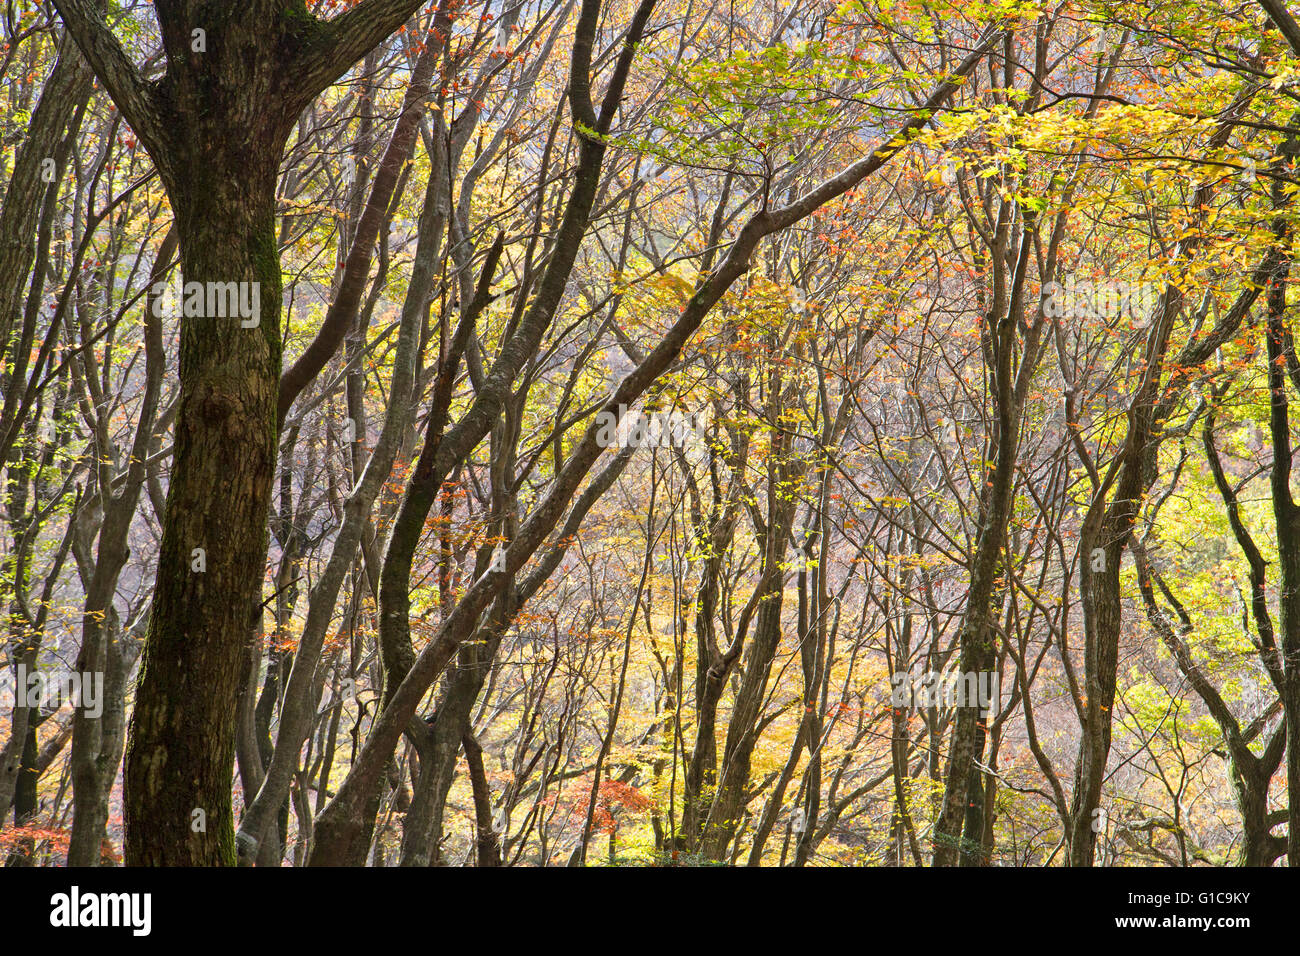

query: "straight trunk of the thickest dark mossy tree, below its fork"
xmin=126 ymin=158 xmax=280 ymax=865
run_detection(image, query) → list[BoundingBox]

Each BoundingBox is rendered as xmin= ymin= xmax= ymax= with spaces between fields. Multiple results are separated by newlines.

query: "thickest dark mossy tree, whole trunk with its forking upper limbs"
xmin=56 ymin=0 xmax=431 ymax=865
